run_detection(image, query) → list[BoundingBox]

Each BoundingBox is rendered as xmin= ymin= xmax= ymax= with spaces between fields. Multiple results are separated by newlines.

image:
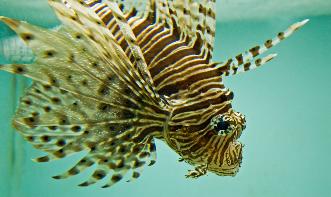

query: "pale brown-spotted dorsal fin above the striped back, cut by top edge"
xmin=157 ymin=0 xmax=216 ymax=59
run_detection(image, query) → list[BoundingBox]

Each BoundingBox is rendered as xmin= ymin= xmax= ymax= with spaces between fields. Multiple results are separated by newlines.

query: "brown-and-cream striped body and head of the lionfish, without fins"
xmin=89 ymin=2 xmax=245 ymax=175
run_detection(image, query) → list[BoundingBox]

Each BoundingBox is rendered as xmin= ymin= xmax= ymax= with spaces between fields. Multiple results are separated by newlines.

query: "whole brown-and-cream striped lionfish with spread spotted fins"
xmin=0 ymin=0 xmax=308 ymax=187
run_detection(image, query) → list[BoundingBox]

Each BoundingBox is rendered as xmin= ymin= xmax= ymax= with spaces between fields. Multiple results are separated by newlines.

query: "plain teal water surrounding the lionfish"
xmin=0 ymin=0 xmax=331 ymax=197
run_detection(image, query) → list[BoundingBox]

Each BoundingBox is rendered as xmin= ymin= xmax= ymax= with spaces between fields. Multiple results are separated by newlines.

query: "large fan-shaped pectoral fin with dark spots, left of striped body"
xmin=0 ymin=1 xmax=166 ymax=187
